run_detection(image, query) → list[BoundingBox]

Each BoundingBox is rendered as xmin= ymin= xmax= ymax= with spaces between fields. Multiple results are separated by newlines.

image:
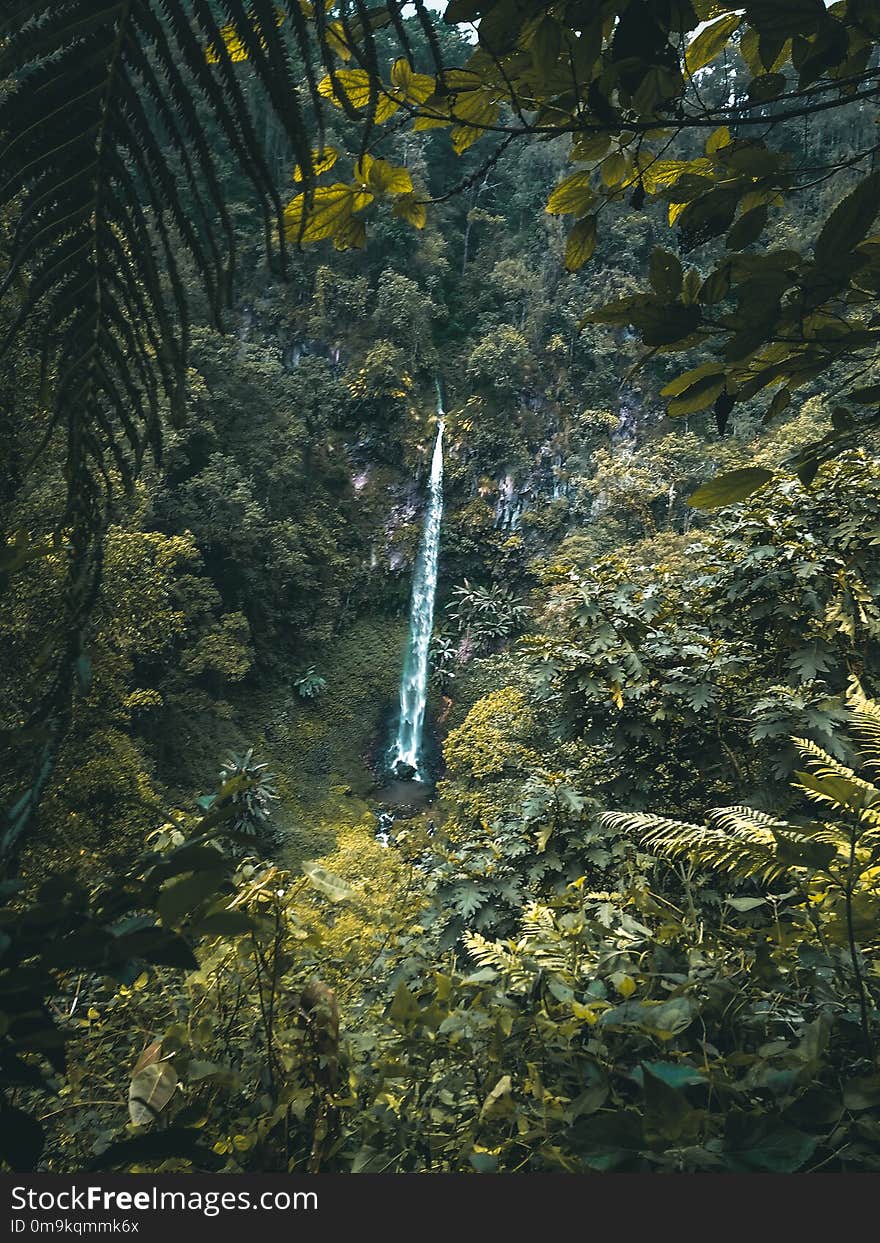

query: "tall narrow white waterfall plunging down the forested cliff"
xmin=389 ymin=385 xmax=444 ymax=781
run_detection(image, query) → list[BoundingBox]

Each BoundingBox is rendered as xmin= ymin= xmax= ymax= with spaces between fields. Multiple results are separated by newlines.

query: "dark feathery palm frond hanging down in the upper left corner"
xmin=0 ymin=0 xmax=437 ymax=854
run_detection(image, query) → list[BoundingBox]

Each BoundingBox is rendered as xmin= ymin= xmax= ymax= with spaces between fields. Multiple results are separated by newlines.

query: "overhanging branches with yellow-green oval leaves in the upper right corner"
xmin=282 ymin=0 xmax=880 ymax=489
